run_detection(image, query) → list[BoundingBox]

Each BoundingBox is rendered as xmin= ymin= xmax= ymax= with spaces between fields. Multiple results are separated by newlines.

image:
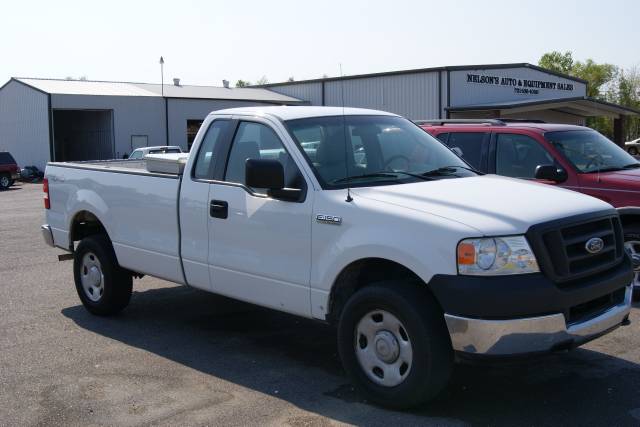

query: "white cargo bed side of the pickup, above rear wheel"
xmin=46 ymin=160 xmax=184 ymax=283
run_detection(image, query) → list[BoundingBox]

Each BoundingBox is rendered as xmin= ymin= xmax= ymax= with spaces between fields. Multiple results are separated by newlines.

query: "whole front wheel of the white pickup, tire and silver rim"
xmin=338 ymin=282 xmax=453 ymax=409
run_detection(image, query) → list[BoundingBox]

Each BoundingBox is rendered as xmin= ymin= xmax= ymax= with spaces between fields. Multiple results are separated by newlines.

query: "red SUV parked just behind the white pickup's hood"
xmin=417 ymin=119 xmax=640 ymax=295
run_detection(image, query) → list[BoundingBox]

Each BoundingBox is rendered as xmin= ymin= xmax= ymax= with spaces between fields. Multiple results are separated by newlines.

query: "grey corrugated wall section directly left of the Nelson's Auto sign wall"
xmin=325 ymin=71 xmax=439 ymax=120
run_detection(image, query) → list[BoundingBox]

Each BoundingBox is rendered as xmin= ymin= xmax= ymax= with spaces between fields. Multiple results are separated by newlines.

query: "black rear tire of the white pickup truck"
xmin=73 ymin=235 xmax=133 ymax=316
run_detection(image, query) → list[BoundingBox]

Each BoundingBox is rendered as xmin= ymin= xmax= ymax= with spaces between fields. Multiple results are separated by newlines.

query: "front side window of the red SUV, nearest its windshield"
xmin=496 ymin=133 xmax=554 ymax=178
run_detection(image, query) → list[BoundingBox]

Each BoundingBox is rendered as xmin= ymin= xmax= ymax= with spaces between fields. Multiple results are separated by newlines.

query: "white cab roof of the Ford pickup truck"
xmin=211 ymin=106 xmax=397 ymax=120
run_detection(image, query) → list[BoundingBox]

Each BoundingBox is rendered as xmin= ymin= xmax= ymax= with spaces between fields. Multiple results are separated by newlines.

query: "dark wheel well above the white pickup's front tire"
xmin=327 ymin=258 xmax=428 ymax=323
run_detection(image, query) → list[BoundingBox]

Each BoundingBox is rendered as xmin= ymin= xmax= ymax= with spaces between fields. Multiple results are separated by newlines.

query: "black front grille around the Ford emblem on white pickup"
xmin=527 ymin=211 xmax=624 ymax=286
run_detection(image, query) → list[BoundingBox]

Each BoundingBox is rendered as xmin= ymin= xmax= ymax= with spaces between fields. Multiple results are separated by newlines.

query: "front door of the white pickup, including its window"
xmin=208 ymin=119 xmax=313 ymax=316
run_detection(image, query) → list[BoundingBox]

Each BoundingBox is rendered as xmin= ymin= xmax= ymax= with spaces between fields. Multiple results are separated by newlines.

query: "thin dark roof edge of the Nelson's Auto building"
xmin=253 ymin=62 xmax=588 ymax=88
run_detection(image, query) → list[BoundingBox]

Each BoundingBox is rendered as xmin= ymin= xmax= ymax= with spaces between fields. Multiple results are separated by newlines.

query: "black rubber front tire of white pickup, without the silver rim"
xmin=338 ymin=282 xmax=453 ymax=409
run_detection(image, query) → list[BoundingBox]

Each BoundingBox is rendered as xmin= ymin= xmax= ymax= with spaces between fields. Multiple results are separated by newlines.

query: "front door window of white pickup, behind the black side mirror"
xmin=224 ymin=122 xmax=304 ymax=194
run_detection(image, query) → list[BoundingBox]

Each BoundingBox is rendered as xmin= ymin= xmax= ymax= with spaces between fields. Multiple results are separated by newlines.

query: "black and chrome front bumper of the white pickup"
xmin=429 ymin=257 xmax=633 ymax=356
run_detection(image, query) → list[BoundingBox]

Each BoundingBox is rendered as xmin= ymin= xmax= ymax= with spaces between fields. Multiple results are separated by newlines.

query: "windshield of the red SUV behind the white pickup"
xmin=544 ymin=130 xmax=640 ymax=173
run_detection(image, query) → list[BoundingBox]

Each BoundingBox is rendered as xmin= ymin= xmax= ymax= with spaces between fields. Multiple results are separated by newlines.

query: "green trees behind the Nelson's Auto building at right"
xmin=538 ymin=51 xmax=640 ymax=141
